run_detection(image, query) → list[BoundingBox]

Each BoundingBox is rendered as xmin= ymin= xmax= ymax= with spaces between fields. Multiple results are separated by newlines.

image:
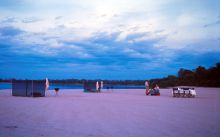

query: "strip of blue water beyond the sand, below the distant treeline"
xmin=0 ymin=83 xmax=145 ymax=89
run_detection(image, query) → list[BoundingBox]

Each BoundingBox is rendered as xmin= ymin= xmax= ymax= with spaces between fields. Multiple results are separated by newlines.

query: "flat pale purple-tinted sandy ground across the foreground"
xmin=0 ymin=88 xmax=220 ymax=137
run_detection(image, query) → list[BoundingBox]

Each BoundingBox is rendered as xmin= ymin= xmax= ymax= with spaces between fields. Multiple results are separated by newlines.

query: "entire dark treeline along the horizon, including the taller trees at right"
xmin=0 ymin=63 xmax=220 ymax=87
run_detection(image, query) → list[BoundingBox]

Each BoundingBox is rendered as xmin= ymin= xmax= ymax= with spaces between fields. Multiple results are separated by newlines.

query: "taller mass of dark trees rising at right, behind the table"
xmin=150 ymin=63 xmax=220 ymax=87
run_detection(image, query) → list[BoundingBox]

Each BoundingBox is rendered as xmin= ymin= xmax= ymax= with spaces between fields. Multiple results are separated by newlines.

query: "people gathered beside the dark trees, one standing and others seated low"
xmin=145 ymin=81 xmax=160 ymax=96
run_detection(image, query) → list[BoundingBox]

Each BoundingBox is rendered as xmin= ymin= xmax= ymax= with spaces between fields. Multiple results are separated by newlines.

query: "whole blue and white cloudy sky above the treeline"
xmin=0 ymin=0 xmax=220 ymax=80
